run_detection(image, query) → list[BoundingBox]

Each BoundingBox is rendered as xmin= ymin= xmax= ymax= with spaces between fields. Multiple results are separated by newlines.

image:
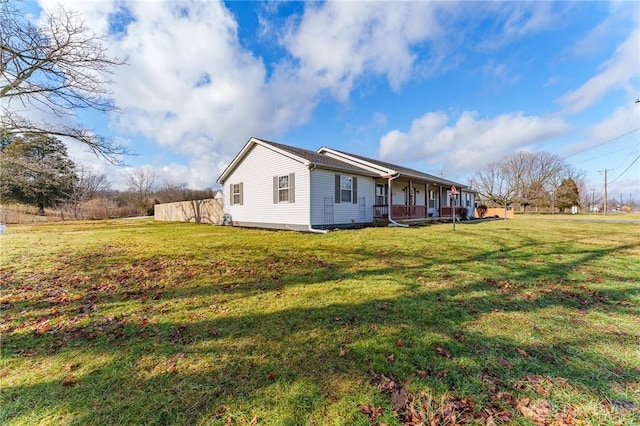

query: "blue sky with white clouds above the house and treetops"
xmin=26 ymin=0 xmax=640 ymax=200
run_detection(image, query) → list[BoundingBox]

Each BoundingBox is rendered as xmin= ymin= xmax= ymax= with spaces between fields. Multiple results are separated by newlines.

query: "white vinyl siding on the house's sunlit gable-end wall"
xmin=224 ymin=145 xmax=309 ymax=228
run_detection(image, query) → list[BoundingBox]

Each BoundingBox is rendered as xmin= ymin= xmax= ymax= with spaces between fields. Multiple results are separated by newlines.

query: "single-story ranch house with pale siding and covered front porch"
xmin=218 ymin=138 xmax=475 ymax=232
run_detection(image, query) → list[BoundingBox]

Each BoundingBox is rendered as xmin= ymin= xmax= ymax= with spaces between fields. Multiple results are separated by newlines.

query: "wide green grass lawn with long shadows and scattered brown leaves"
xmin=0 ymin=216 xmax=640 ymax=425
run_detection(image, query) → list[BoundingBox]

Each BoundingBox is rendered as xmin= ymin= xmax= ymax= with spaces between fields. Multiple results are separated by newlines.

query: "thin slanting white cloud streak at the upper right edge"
xmin=559 ymin=28 xmax=640 ymax=113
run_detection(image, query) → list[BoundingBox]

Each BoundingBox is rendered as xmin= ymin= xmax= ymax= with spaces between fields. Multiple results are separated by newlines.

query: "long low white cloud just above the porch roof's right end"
xmin=379 ymin=111 xmax=569 ymax=173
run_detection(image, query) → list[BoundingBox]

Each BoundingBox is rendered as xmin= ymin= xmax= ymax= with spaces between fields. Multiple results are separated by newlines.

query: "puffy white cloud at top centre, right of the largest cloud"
xmin=282 ymin=2 xmax=441 ymax=95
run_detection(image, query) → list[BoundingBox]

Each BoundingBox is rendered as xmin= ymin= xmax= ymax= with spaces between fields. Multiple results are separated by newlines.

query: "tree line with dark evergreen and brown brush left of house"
xmin=0 ymin=132 xmax=216 ymax=219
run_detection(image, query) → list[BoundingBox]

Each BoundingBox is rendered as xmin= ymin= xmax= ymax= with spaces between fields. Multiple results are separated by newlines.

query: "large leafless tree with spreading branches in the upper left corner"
xmin=0 ymin=0 xmax=127 ymax=163
